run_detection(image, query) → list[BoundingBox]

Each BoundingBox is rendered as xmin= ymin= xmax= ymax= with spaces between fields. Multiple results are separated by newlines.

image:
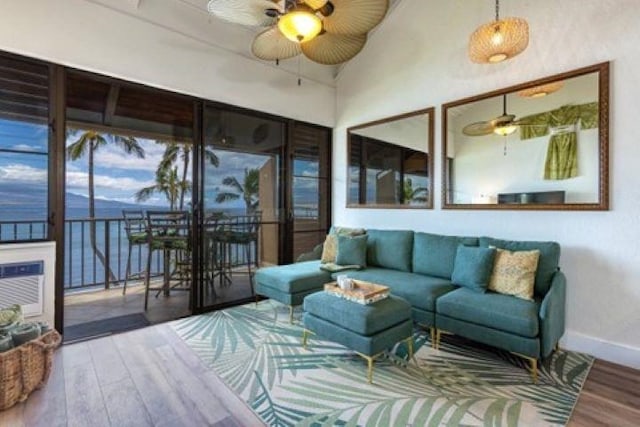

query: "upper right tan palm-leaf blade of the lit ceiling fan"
xmin=322 ymin=0 xmax=389 ymax=35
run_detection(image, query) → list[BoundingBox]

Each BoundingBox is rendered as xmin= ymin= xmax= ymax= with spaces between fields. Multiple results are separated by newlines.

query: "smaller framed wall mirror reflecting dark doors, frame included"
xmin=347 ymin=107 xmax=434 ymax=209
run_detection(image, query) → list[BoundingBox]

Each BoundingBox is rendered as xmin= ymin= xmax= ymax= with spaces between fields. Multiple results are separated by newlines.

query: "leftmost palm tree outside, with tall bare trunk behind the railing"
xmin=67 ymin=130 xmax=144 ymax=281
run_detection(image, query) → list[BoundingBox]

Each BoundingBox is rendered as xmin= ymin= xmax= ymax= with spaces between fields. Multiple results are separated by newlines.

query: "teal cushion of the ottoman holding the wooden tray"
xmin=303 ymin=292 xmax=411 ymax=338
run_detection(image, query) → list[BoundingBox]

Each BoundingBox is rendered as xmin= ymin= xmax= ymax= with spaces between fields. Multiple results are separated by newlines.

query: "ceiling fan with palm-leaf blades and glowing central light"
xmin=207 ymin=0 xmax=389 ymax=65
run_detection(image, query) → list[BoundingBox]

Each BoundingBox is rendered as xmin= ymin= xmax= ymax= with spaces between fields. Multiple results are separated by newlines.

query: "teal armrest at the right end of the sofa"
xmin=540 ymin=271 xmax=567 ymax=357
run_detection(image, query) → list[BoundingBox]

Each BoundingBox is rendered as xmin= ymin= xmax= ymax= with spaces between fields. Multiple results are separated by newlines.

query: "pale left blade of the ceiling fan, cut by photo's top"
xmin=207 ymin=0 xmax=276 ymax=27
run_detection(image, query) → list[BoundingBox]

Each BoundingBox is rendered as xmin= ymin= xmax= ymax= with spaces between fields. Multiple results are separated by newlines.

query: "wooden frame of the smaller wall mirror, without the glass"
xmin=346 ymin=107 xmax=435 ymax=209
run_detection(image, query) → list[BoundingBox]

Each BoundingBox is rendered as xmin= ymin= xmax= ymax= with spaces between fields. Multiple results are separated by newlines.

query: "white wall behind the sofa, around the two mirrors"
xmin=333 ymin=0 xmax=640 ymax=367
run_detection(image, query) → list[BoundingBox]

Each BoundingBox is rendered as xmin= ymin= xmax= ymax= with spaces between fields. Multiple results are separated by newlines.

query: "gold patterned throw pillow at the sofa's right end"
xmin=489 ymin=248 xmax=540 ymax=300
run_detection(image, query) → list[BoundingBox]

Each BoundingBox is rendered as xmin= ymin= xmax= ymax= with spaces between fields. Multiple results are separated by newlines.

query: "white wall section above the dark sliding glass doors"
xmin=0 ymin=0 xmax=335 ymax=126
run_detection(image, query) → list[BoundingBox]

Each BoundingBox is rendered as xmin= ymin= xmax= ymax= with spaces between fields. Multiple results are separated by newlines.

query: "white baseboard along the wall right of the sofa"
xmin=560 ymin=331 xmax=640 ymax=369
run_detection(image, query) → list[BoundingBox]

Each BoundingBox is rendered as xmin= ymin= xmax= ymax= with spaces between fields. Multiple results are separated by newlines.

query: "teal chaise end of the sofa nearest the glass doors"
xmin=255 ymin=261 xmax=332 ymax=322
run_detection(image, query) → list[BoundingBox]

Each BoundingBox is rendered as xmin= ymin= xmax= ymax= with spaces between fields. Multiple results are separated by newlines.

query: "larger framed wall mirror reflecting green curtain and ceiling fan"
xmin=442 ymin=62 xmax=609 ymax=210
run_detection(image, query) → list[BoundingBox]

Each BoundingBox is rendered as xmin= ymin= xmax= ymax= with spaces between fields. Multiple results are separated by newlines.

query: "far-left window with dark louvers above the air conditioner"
xmin=0 ymin=56 xmax=49 ymax=242
